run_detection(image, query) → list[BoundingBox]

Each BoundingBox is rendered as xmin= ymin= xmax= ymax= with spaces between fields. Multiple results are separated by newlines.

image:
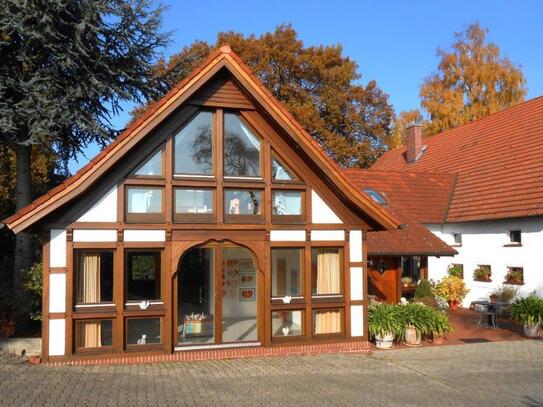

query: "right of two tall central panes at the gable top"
xmin=224 ymin=113 xmax=261 ymax=177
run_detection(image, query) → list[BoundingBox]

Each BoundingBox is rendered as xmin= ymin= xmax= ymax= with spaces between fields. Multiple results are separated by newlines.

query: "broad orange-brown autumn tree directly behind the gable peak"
xmin=134 ymin=25 xmax=393 ymax=167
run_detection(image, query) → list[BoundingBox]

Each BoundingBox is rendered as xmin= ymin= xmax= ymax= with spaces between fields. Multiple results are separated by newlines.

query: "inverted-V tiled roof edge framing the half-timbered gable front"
xmin=4 ymin=46 xmax=398 ymax=233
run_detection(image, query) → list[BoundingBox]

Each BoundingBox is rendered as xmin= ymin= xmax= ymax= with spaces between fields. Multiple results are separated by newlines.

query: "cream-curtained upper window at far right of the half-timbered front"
xmin=311 ymin=248 xmax=343 ymax=295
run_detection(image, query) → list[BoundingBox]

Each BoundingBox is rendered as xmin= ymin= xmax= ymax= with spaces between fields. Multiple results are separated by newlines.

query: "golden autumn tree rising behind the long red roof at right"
xmin=420 ymin=24 xmax=526 ymax=134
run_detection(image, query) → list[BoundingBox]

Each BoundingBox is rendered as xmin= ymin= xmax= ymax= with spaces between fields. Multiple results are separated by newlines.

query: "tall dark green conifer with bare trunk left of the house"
xmin=0 ymin=0 xmax=169 ymax=316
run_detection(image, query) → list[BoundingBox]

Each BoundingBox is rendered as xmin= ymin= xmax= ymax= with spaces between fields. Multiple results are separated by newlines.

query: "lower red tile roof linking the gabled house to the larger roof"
xmin=343 ymin=169 xmax=456 ymax=256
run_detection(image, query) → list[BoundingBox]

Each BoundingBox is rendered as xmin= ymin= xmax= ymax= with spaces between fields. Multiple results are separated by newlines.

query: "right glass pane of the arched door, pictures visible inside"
xmin=221 ymin=247 xmax=258 ymax=343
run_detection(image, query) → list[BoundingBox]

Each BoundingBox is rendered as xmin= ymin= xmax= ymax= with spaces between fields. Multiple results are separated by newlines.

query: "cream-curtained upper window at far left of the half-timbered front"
xmin=75 ymin=251 xmax=113 ymax=304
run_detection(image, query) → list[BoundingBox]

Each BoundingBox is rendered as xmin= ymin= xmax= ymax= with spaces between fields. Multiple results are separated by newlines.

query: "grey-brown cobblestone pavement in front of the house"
xmin=0 ymin=341 xmax=543 ymax=406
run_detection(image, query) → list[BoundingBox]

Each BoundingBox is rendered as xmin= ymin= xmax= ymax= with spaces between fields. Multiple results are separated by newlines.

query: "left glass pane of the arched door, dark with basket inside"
xmin=177 ymin=247 xmax=215 ymax=345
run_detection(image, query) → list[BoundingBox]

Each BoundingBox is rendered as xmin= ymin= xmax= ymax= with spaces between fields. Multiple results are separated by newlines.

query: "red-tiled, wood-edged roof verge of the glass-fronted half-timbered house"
xmin=3 ymin=45 xmax=398 ymax=232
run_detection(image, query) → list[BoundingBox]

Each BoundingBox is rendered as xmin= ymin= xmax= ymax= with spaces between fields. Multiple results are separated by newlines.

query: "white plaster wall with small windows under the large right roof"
xmin=427 ymin=217 xmax=543 ymax=306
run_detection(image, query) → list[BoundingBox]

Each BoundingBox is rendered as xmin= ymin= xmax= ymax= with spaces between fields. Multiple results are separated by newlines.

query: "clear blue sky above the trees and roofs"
xmin=70 ymin=0 xmax=543 ymax=172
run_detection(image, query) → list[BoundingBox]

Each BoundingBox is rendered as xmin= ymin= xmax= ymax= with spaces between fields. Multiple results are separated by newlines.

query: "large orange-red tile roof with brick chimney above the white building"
xmin=372 ymin=97 xmax=543 ymax=222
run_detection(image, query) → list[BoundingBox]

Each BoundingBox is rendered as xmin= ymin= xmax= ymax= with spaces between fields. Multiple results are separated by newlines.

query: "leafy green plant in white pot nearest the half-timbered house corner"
xmin=368 ymin=303 xmax=403 ymax=349
